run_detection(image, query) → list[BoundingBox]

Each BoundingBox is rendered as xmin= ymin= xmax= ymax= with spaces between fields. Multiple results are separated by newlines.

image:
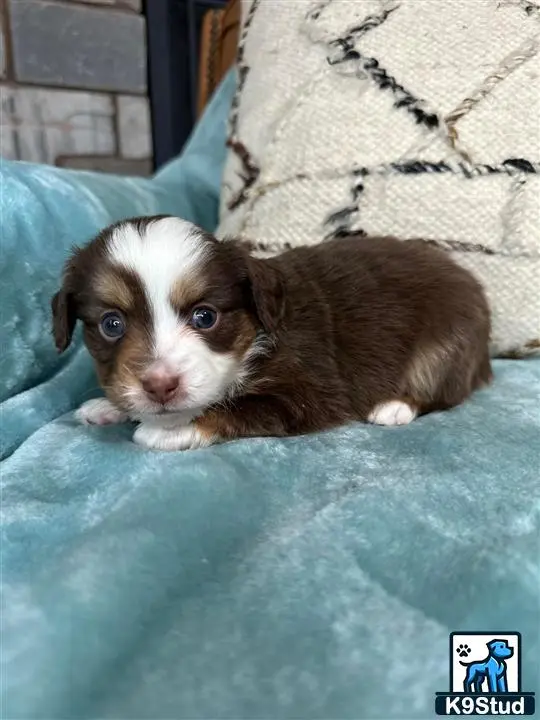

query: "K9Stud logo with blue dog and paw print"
xmin=435 ymin=632 xmax=535 ymax=715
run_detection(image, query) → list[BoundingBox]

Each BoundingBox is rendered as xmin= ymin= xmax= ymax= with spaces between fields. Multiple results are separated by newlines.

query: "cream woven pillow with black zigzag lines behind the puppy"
xmin=218 ymin=0 xmax=540 ymax=356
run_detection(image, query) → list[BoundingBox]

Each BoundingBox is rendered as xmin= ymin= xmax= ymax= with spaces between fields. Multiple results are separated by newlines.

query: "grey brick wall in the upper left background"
xmin=0 ymin=0 xmax=152 ymax=175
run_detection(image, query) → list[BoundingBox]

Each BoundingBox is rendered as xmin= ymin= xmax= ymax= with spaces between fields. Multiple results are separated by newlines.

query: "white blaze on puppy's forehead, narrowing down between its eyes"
xmin=108 ymin=218 xmax=208 ymax=357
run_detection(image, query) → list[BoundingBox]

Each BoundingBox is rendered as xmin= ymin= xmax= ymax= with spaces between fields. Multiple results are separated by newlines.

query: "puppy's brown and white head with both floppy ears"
xmin=52 ymin=217 xmax=283 ymax=417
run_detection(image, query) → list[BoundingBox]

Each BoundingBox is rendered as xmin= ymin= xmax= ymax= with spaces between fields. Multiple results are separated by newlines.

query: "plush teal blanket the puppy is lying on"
xmin=0 ymin=70 xmax=540 ymax=720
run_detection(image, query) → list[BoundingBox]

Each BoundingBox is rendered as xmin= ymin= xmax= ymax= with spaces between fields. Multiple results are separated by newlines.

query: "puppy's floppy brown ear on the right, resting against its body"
xmin=247 ymin=255 xmax=285 ymax=333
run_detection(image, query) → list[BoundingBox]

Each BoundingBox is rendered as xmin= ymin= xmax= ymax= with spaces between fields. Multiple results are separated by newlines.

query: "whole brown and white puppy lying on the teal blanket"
xmin=52 ymin=217 xmax=491 ymax=450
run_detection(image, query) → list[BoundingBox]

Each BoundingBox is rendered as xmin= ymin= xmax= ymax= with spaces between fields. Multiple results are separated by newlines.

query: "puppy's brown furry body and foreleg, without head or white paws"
xmin=197 ymin=238 xmax=491 ymax=438
